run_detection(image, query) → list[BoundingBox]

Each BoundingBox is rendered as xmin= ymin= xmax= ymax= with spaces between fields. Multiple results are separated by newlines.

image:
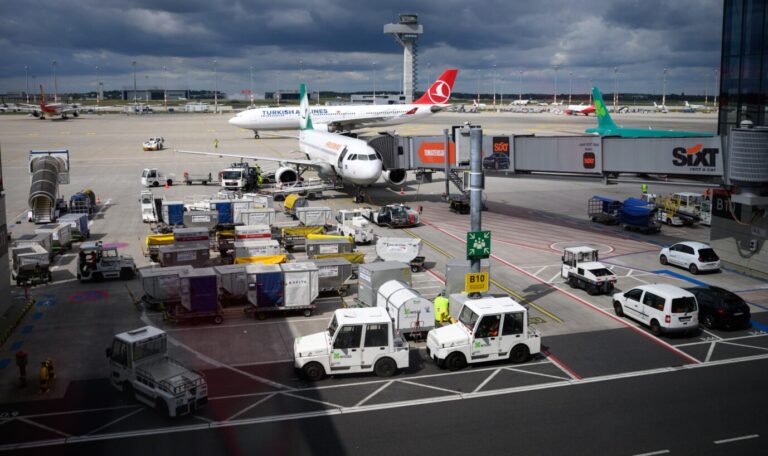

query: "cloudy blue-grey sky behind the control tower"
xmin=0 ymin=0 xmax=723 ymax=96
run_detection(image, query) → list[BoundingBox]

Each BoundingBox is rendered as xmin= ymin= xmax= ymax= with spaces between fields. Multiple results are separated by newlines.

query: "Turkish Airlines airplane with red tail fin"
xmin=229 ymin=69 xmax=458 ymax=138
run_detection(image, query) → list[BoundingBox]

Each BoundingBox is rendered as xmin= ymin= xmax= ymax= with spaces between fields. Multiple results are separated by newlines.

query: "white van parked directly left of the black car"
xmin=613 ymin=284 xmax=699 ymax=336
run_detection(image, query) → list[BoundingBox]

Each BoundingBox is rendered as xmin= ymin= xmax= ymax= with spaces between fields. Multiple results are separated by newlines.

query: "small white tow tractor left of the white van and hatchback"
xmin=560 ymin=246 xmax=617 ymax=295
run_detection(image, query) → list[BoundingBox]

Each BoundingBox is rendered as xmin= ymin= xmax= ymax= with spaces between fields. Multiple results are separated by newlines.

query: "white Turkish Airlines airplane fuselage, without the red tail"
xmin=229 ymin=104 xmax=435 ymax=131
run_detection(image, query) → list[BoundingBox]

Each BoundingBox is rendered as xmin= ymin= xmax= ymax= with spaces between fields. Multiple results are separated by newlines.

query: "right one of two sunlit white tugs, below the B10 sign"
xmin=427 ymin=294 xmax=541 ymax=371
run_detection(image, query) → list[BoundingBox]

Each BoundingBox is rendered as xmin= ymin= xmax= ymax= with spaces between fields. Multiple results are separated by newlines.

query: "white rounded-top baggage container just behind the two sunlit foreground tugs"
xmin=376 ymin=280 xmax=435 ymax=338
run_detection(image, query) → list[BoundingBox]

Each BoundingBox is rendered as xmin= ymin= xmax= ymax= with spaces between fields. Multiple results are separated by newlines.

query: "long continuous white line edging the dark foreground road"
xmin=0 ymin=354 xmax=768 ymax=451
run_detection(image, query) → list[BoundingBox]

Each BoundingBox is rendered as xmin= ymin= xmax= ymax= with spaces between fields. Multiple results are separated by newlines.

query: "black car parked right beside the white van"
xmin=688 ymin=287 xmax=751 ymax=328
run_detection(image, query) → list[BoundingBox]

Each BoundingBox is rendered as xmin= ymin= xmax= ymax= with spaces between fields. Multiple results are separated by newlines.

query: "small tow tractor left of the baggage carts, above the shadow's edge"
xmin=77 ymin=241 xmax=136 ymax=282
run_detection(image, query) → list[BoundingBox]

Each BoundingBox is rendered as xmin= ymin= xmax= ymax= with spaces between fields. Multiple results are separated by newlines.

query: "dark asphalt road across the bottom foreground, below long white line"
xmin=4 ymin=359 xmax=768 ymax=456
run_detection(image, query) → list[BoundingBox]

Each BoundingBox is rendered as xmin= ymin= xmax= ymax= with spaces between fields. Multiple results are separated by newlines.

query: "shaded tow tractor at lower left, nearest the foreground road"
xmin=106 ymin=326 xmax=208 ymax=417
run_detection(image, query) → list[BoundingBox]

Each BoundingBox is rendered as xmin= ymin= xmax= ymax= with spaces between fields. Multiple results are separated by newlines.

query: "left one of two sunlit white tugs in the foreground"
xmin=293 ymin=307 xmax=409 ymax=381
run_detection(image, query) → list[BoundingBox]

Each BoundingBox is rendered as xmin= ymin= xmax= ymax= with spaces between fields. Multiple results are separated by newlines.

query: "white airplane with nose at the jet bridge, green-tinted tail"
xmin=178 ymin=84 xmax=390 ymax=202
